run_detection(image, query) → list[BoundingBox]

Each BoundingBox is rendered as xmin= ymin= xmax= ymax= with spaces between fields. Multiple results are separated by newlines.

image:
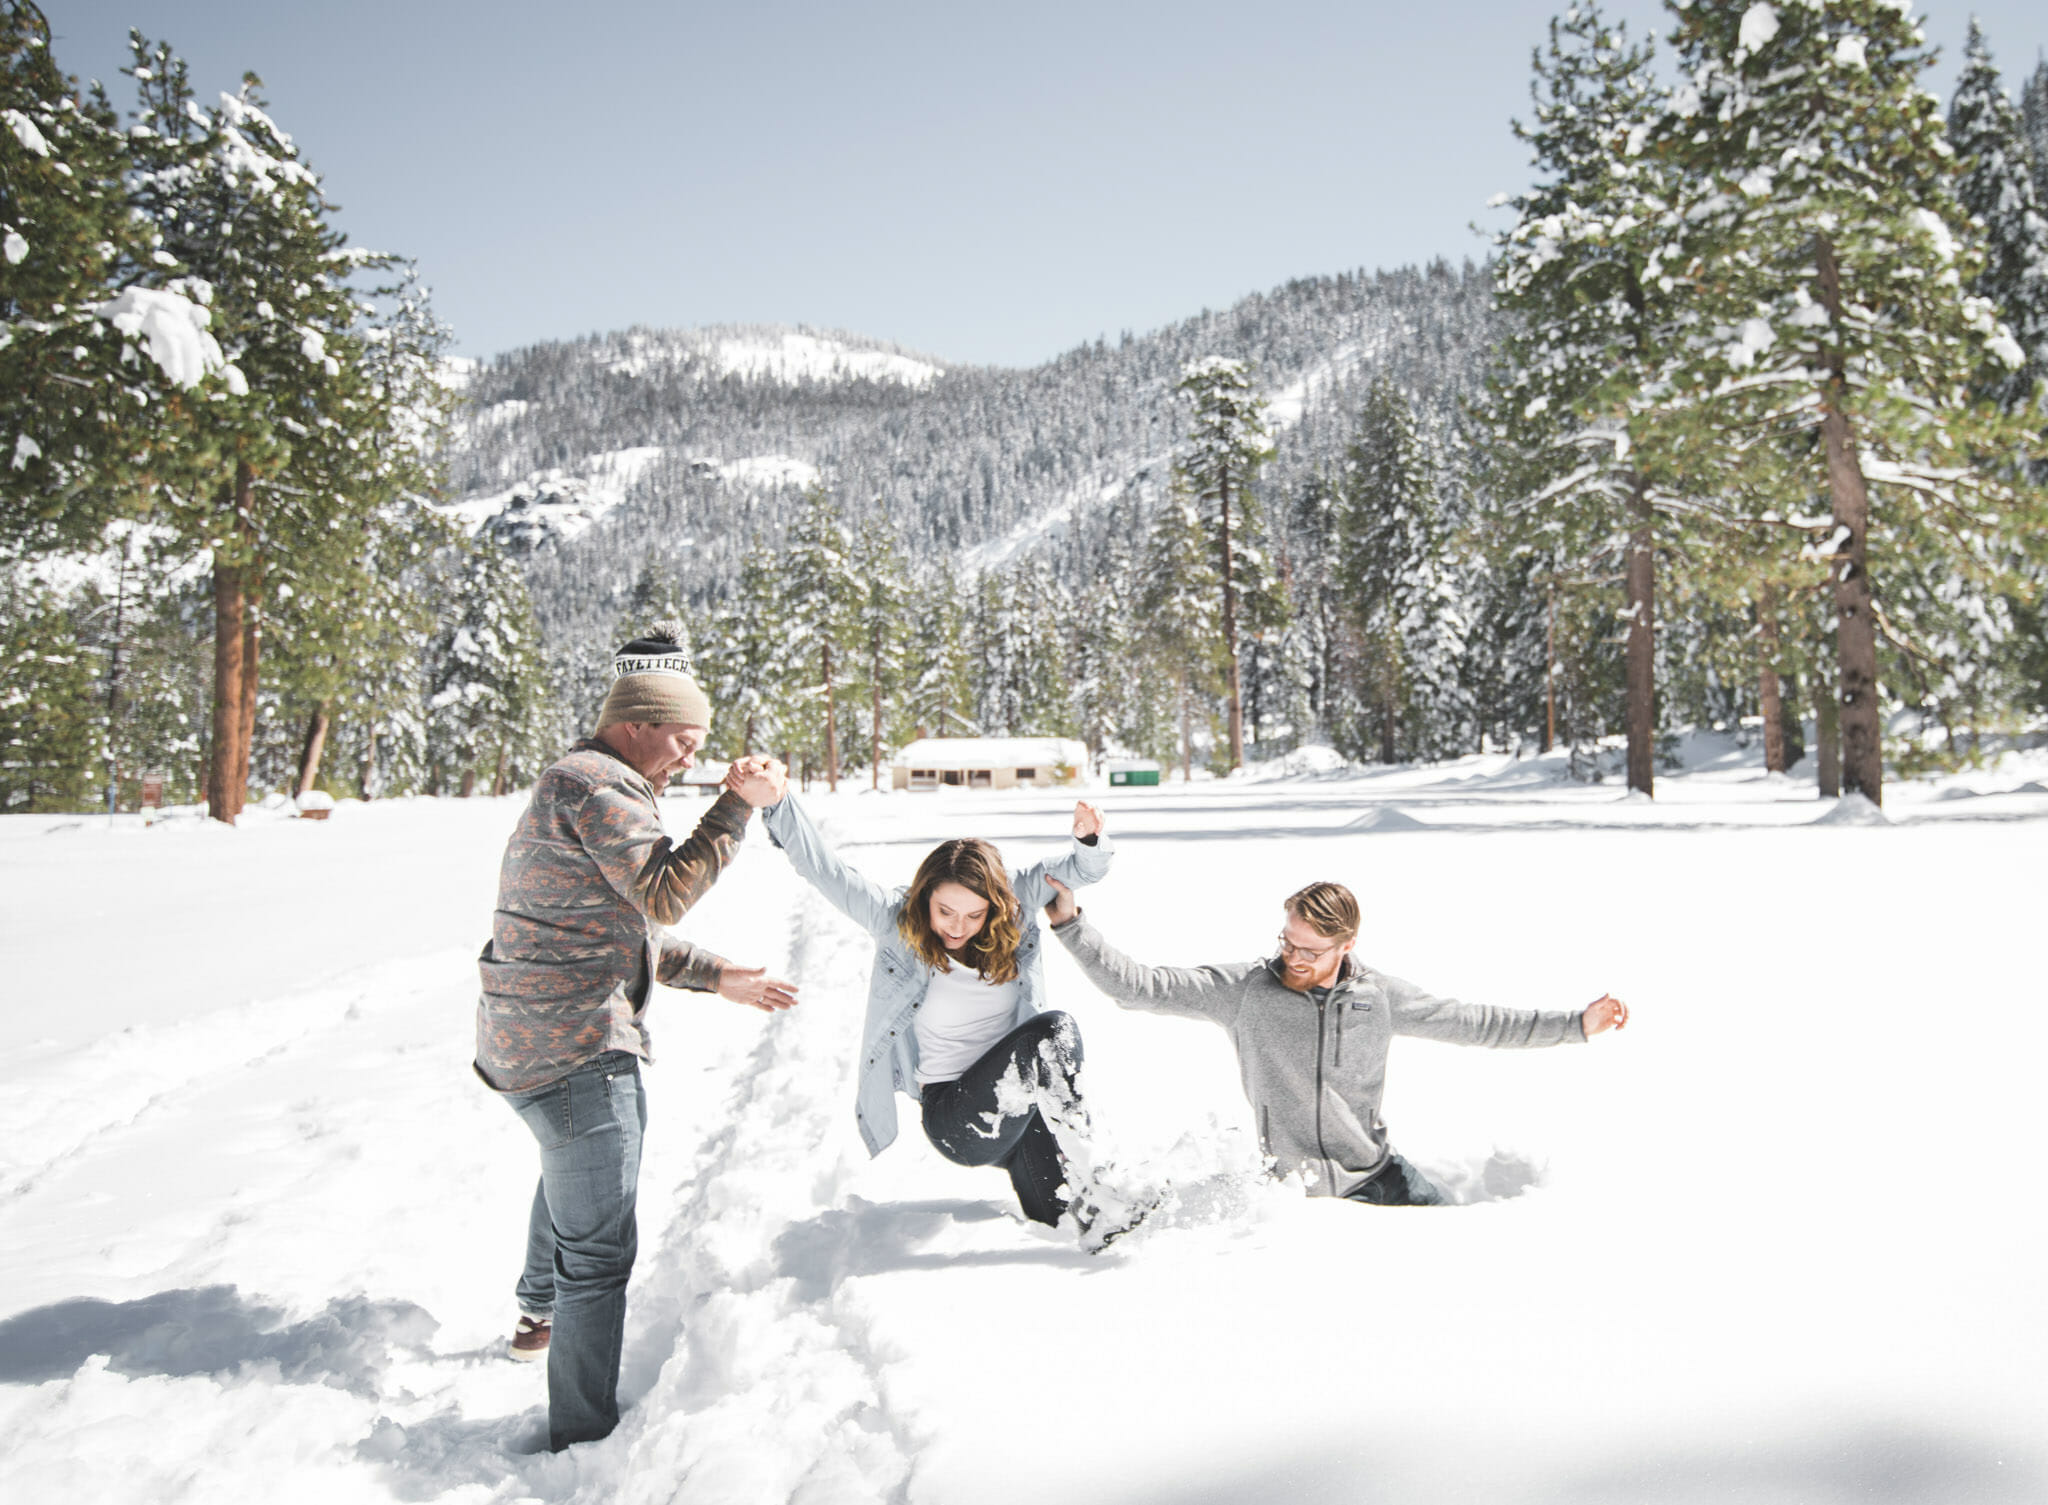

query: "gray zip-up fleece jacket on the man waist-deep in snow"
xmin=1053 ymin=915 xmax=1585 ymax=1196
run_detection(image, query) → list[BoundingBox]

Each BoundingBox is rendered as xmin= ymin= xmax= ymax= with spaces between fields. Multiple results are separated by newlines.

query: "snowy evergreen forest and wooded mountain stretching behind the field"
xmin=0 ymin=0 xmax=2048 ymax=821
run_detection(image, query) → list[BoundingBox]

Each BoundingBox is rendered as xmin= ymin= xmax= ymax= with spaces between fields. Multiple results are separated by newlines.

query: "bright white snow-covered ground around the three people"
xmin=0 ymin=747 xmax=2048 ymax=1505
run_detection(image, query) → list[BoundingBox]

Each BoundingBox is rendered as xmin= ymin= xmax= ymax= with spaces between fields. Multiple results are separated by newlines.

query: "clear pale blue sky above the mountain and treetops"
xmin=43 ymin=0 xmax=2048 ymax=364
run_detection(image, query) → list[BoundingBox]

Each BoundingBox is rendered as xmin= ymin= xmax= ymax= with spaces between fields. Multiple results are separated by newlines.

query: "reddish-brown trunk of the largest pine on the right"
xmin=1815 ymin=235 xmax=1884 ymax=805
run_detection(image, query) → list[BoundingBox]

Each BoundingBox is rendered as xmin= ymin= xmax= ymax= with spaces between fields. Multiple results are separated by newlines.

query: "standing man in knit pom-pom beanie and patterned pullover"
xmin=475 ymin=622 xmax=797 ymax=1452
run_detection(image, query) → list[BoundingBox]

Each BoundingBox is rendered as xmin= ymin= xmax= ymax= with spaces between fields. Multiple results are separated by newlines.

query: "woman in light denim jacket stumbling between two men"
xmin=731 ymin=766 xmax=1120 ymax=1243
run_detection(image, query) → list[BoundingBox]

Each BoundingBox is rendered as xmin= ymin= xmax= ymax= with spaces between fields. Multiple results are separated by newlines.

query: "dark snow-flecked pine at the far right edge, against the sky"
xmin=1948 ymin=16 xmax=2048 ymax=410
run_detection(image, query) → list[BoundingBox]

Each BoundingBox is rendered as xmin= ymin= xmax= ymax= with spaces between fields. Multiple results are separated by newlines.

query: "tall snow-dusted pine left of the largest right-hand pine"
xmin=1491 ymin=4 xmax=1681 ymax=794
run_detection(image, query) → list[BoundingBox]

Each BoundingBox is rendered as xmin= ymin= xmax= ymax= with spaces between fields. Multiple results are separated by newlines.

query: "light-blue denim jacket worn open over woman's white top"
xmin=762 ymin=797 xmax=1110 ymax=1155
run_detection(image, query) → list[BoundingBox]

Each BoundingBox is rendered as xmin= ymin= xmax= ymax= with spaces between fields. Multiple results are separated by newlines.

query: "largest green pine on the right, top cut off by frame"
xmin=1669 ymin=0 xmax=2036 ymax=801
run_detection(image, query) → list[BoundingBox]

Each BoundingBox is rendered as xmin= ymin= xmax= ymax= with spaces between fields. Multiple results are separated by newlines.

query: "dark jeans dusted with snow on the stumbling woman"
xmin=924 ymin=1009 xmax=1083 ymax=1224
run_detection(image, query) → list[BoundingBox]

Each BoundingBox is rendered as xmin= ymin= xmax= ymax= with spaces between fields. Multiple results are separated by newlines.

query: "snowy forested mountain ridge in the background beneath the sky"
xmin=446 ymin=262 xmax=1499 ymax=647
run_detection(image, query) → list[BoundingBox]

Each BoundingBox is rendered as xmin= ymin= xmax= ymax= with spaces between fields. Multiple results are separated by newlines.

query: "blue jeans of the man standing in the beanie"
xmin=506 ymin=1050 xmax=647 ymax=1452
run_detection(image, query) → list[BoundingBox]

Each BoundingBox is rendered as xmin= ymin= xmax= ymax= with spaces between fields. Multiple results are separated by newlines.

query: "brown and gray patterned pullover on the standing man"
xmin=477 ymin=739 xmax=752 ymax=1091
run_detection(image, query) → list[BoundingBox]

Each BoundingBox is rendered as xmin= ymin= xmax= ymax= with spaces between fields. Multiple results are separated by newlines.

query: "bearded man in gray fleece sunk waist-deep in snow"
xmin=1044 ymin=880 xmax=1628 ymax=1208
